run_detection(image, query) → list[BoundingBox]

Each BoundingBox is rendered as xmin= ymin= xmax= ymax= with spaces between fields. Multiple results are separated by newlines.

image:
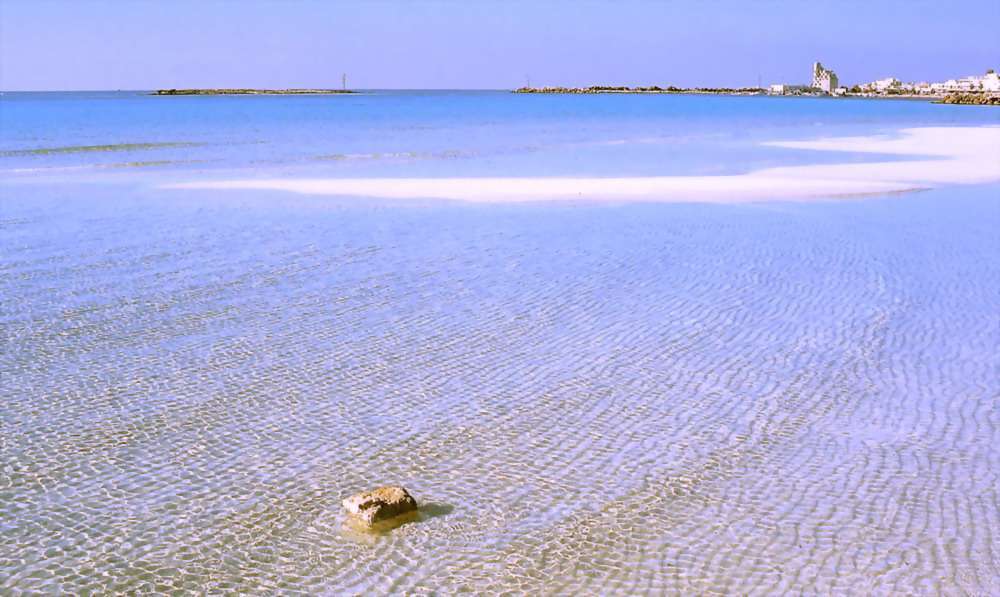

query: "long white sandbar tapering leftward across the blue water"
xmin=170 ymin=127 xmax=1000 ymax=203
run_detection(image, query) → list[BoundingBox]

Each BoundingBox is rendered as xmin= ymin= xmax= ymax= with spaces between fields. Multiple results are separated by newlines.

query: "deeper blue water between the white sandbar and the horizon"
xmin=0 ymin=92 xmax=1000 ymax=182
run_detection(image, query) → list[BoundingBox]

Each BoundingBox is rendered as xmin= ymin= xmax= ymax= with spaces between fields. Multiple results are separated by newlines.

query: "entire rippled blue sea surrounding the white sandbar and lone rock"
xmin=0 ymin=91 xmax=1000 ymax=595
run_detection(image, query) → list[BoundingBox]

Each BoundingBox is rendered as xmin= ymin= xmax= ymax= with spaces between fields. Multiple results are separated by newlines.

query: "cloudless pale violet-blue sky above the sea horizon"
xmin=0 ymin=0 xmax=1000 ymax=90
